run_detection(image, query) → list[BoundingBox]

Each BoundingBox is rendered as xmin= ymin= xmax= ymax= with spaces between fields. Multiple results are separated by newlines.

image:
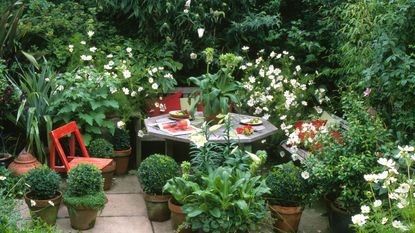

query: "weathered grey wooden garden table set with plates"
xmin=144 ymin=112 xmax=277 ymax=155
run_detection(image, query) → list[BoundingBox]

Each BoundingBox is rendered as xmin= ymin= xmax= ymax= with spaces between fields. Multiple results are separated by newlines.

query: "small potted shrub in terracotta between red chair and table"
xmin=112 ymin=128 xmax=131 ymax=175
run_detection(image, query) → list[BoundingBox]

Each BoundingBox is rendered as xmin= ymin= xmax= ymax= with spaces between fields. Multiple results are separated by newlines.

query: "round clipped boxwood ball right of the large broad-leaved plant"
xmin=266 ymin=162 xmax=311 ymax=206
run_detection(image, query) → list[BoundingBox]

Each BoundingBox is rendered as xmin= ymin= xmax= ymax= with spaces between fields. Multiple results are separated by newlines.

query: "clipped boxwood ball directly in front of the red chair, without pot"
xmin=65 ymin=163 xmax=104 ymax=197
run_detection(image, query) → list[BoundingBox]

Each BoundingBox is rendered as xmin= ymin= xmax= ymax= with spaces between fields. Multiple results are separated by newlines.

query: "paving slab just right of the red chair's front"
xmin=107 ymin=174 xmax=143 ymax=193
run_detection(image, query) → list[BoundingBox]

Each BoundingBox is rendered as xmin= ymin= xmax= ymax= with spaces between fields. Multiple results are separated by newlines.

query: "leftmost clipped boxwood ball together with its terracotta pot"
xmin=24 ymin=166 xmax=62 ymax=225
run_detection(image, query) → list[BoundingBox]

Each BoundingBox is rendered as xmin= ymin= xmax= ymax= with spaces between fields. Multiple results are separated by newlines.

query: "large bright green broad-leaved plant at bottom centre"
xmin=183 ymin=167 xmax=269 ymax=232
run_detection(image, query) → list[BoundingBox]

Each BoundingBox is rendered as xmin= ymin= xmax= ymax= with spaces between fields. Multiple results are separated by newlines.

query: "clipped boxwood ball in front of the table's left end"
xmin=137 ymin=154 xmax=180 ymax=194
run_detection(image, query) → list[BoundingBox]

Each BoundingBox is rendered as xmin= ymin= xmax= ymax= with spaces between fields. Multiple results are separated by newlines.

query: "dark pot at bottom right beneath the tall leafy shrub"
xmin=329 ymin=201 xmax=356 ymax=233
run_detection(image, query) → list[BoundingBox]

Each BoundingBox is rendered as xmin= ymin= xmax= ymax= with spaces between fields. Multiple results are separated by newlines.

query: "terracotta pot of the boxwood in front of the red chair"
xmin=66 ymin=205 xmax=99 ymax=230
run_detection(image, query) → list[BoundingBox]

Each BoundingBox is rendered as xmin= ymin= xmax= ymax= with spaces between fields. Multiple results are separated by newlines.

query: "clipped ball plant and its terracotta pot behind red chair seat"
xmin=88 ymin=138 xmax=117 ymax=190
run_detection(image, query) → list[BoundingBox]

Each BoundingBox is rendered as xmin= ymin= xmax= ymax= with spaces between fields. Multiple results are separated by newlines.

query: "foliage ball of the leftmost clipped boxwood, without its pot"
xmin=26 ymin=166 xmax=61 ymax=200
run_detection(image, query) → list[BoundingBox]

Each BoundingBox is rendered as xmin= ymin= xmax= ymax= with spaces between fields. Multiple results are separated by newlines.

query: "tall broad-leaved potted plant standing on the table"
xmin=189 ymin=48 xmax=242 ymax=121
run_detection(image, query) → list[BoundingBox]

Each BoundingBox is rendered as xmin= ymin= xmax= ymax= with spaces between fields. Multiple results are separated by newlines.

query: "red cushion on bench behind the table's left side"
xmin=147 ymin=91 xmax=182 ymax=117
